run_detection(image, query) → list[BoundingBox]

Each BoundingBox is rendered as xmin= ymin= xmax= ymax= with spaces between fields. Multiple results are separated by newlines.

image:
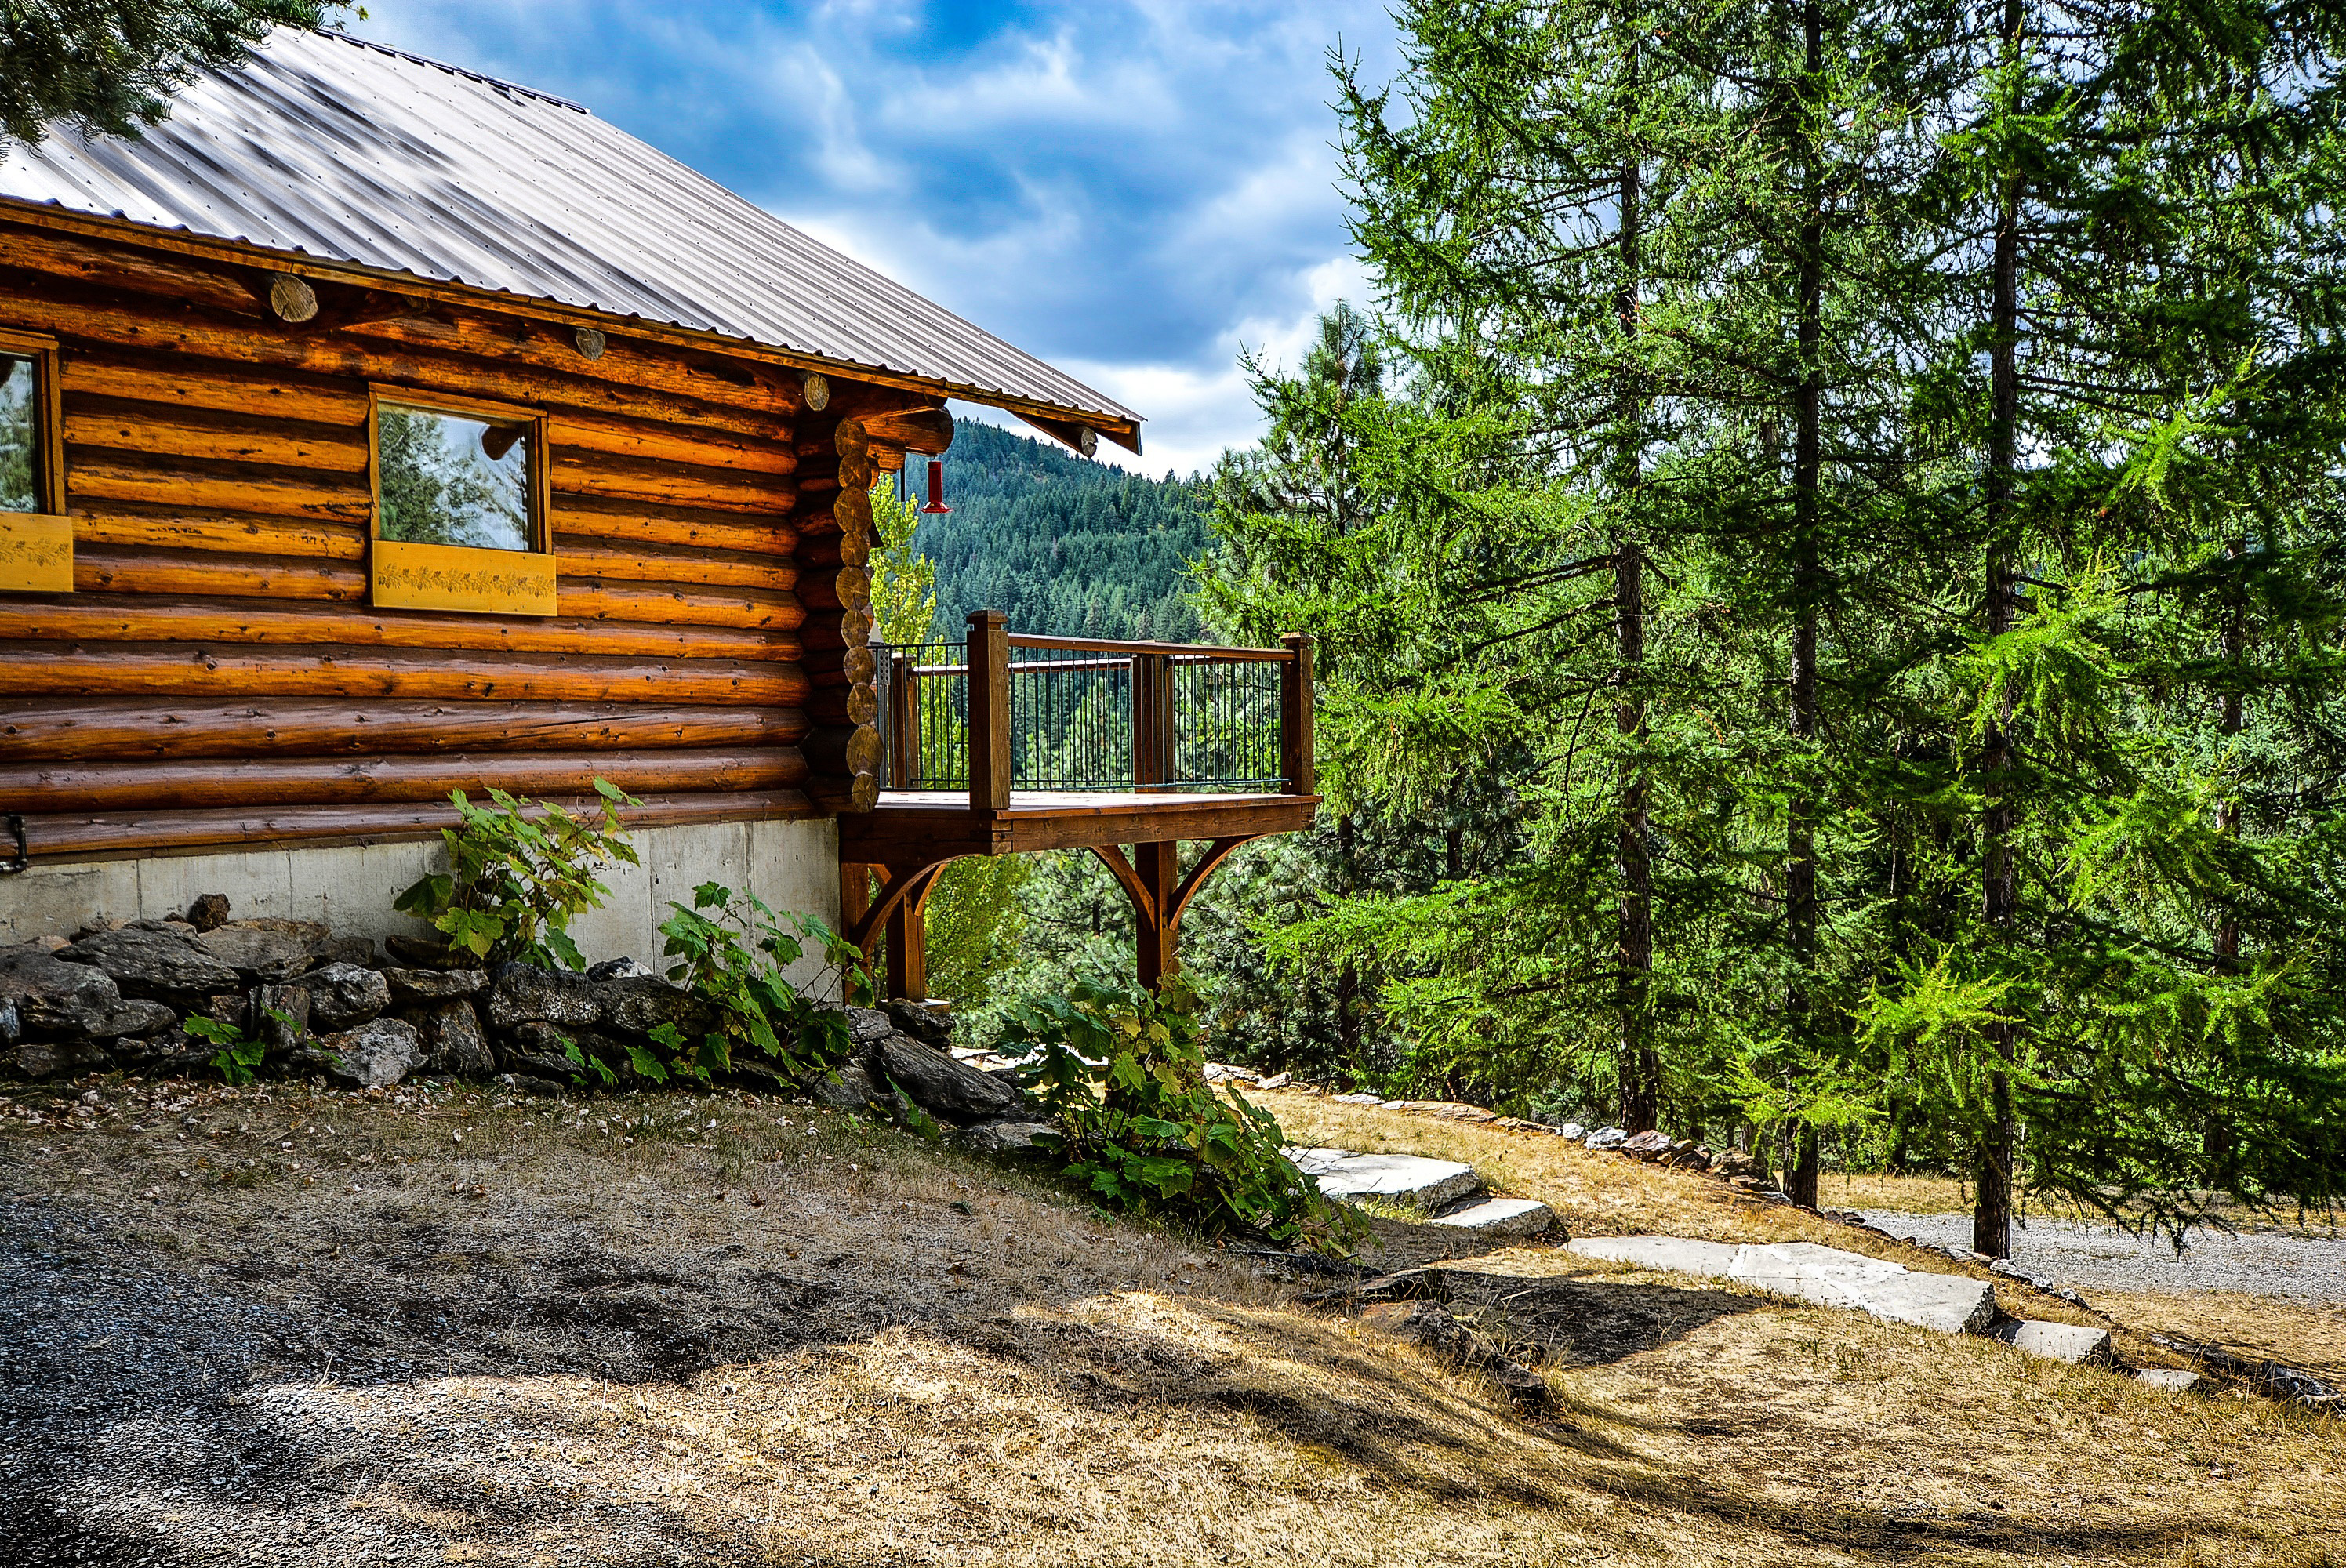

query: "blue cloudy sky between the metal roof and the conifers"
xmin=345 ymin=0 xmax=1393 ymax=472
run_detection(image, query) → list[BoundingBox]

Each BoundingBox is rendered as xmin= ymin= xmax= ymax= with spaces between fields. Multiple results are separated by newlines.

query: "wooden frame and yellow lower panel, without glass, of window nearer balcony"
xmin=366 ymin=383 xmax=558 ymax=615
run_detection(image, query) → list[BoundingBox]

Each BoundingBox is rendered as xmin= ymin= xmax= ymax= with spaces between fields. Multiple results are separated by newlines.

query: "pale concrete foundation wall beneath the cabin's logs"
xmin=0 ymin=819 xmax=840 ymax=983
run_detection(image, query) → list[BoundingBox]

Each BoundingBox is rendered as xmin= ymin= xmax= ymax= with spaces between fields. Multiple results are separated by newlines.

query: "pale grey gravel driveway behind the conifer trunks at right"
xmin=1865 ymin=1209 xmax=2346 ymax=1301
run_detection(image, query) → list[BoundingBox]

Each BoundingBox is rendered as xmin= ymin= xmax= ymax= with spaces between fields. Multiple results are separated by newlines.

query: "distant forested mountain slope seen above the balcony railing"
xmin=915 ymin=420 xmax=1206 ymax=641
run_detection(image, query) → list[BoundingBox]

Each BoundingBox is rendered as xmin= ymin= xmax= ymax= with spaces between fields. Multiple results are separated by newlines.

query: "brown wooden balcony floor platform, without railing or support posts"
xmin=840 ymin=789 xmax=1319 ymax=866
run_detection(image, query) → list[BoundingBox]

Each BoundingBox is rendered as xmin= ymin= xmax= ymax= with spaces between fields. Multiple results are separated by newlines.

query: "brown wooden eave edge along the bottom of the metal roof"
xmin=0 ymin=197 xmax=1140 ymax=456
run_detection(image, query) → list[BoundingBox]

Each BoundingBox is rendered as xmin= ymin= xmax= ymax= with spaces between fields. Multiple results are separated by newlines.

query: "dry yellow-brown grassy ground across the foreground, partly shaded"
xmin=13 ymin=1082 xmax=2346 ymax=1568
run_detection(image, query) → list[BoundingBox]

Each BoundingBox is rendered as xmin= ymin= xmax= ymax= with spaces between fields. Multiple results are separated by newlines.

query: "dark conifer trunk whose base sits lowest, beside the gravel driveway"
xmin=1970 ymin=0 xmax=2022 ymax=1258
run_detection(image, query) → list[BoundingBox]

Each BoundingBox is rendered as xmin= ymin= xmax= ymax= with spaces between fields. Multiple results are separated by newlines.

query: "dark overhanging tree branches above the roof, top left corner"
xmin=0 ymin=0 xmax=330 ymax=143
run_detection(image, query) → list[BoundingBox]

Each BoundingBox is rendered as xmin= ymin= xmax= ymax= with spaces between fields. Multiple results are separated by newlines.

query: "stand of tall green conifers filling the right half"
xmin=1182 ymin=0 xmax=2346 ymax=1247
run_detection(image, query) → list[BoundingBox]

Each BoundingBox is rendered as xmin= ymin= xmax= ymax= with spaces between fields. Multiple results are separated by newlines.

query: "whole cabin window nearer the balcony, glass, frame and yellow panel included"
xmin=373 ymin=387 xmax=556 ymax=615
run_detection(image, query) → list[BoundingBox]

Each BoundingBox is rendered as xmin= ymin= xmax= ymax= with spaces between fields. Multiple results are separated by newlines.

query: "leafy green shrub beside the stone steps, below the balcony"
xmin=1004 ymin=979 xmax=1363 ymax=1254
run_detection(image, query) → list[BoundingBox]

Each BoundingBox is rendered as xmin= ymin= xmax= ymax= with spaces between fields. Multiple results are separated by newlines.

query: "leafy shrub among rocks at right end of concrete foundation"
xmin=656 ymin=883 xmax=873 ymax=1082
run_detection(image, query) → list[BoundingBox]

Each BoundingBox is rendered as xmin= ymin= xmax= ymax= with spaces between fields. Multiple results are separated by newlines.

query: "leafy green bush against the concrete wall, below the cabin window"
xmin=392 ymin=779 xmax=638 ymax=970
